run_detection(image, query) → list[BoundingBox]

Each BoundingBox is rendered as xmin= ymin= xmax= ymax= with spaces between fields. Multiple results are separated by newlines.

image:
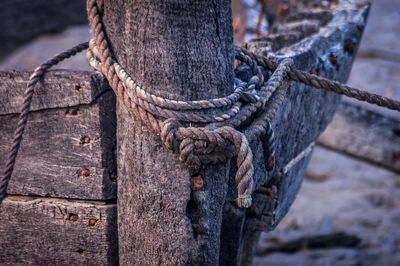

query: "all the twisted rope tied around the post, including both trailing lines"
xmin=0 ymin=0 xmax=400 ymax=208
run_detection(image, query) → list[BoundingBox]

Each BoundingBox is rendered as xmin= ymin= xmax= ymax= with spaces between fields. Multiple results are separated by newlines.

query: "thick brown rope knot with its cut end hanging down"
xmin=161 ymin=119 xmax=254 ymax=208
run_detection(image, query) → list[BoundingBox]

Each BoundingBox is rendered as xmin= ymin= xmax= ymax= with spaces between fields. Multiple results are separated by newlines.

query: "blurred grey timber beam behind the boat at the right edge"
xmin=318 ymin=102 xmax=400 ymax=173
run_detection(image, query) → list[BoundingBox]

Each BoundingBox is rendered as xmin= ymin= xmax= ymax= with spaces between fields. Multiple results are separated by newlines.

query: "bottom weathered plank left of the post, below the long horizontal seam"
xmin=0 ymin=196 xmax=118 ymax=265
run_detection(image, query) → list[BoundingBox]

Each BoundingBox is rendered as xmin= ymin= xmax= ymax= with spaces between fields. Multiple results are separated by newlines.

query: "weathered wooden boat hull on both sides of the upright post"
xmin=0 ymin=1 xmax=368 ymax=265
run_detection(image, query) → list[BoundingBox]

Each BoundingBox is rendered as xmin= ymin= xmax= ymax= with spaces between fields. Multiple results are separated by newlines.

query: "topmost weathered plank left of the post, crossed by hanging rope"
xmin=0 ymin=70 xmax=108 ymax=116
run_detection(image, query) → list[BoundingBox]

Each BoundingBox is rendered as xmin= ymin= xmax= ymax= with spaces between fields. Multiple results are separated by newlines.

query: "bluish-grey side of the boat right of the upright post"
xmin=220 ymin=1 xmax=368 ymax=265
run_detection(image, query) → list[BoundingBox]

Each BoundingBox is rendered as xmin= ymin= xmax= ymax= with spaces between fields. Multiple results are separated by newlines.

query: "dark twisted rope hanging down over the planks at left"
xmin=0 ymin=42 xmax=88 ymax=203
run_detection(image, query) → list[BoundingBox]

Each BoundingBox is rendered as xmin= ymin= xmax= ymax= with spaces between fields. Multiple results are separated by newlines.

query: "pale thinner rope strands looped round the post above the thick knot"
xmin=86 ymin=39 xmax=258 ymax=123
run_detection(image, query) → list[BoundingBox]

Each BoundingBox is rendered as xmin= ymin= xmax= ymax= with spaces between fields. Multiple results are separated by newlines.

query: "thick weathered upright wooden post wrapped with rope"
xmin=103 ymin=0 xmax=234 ymax=265
